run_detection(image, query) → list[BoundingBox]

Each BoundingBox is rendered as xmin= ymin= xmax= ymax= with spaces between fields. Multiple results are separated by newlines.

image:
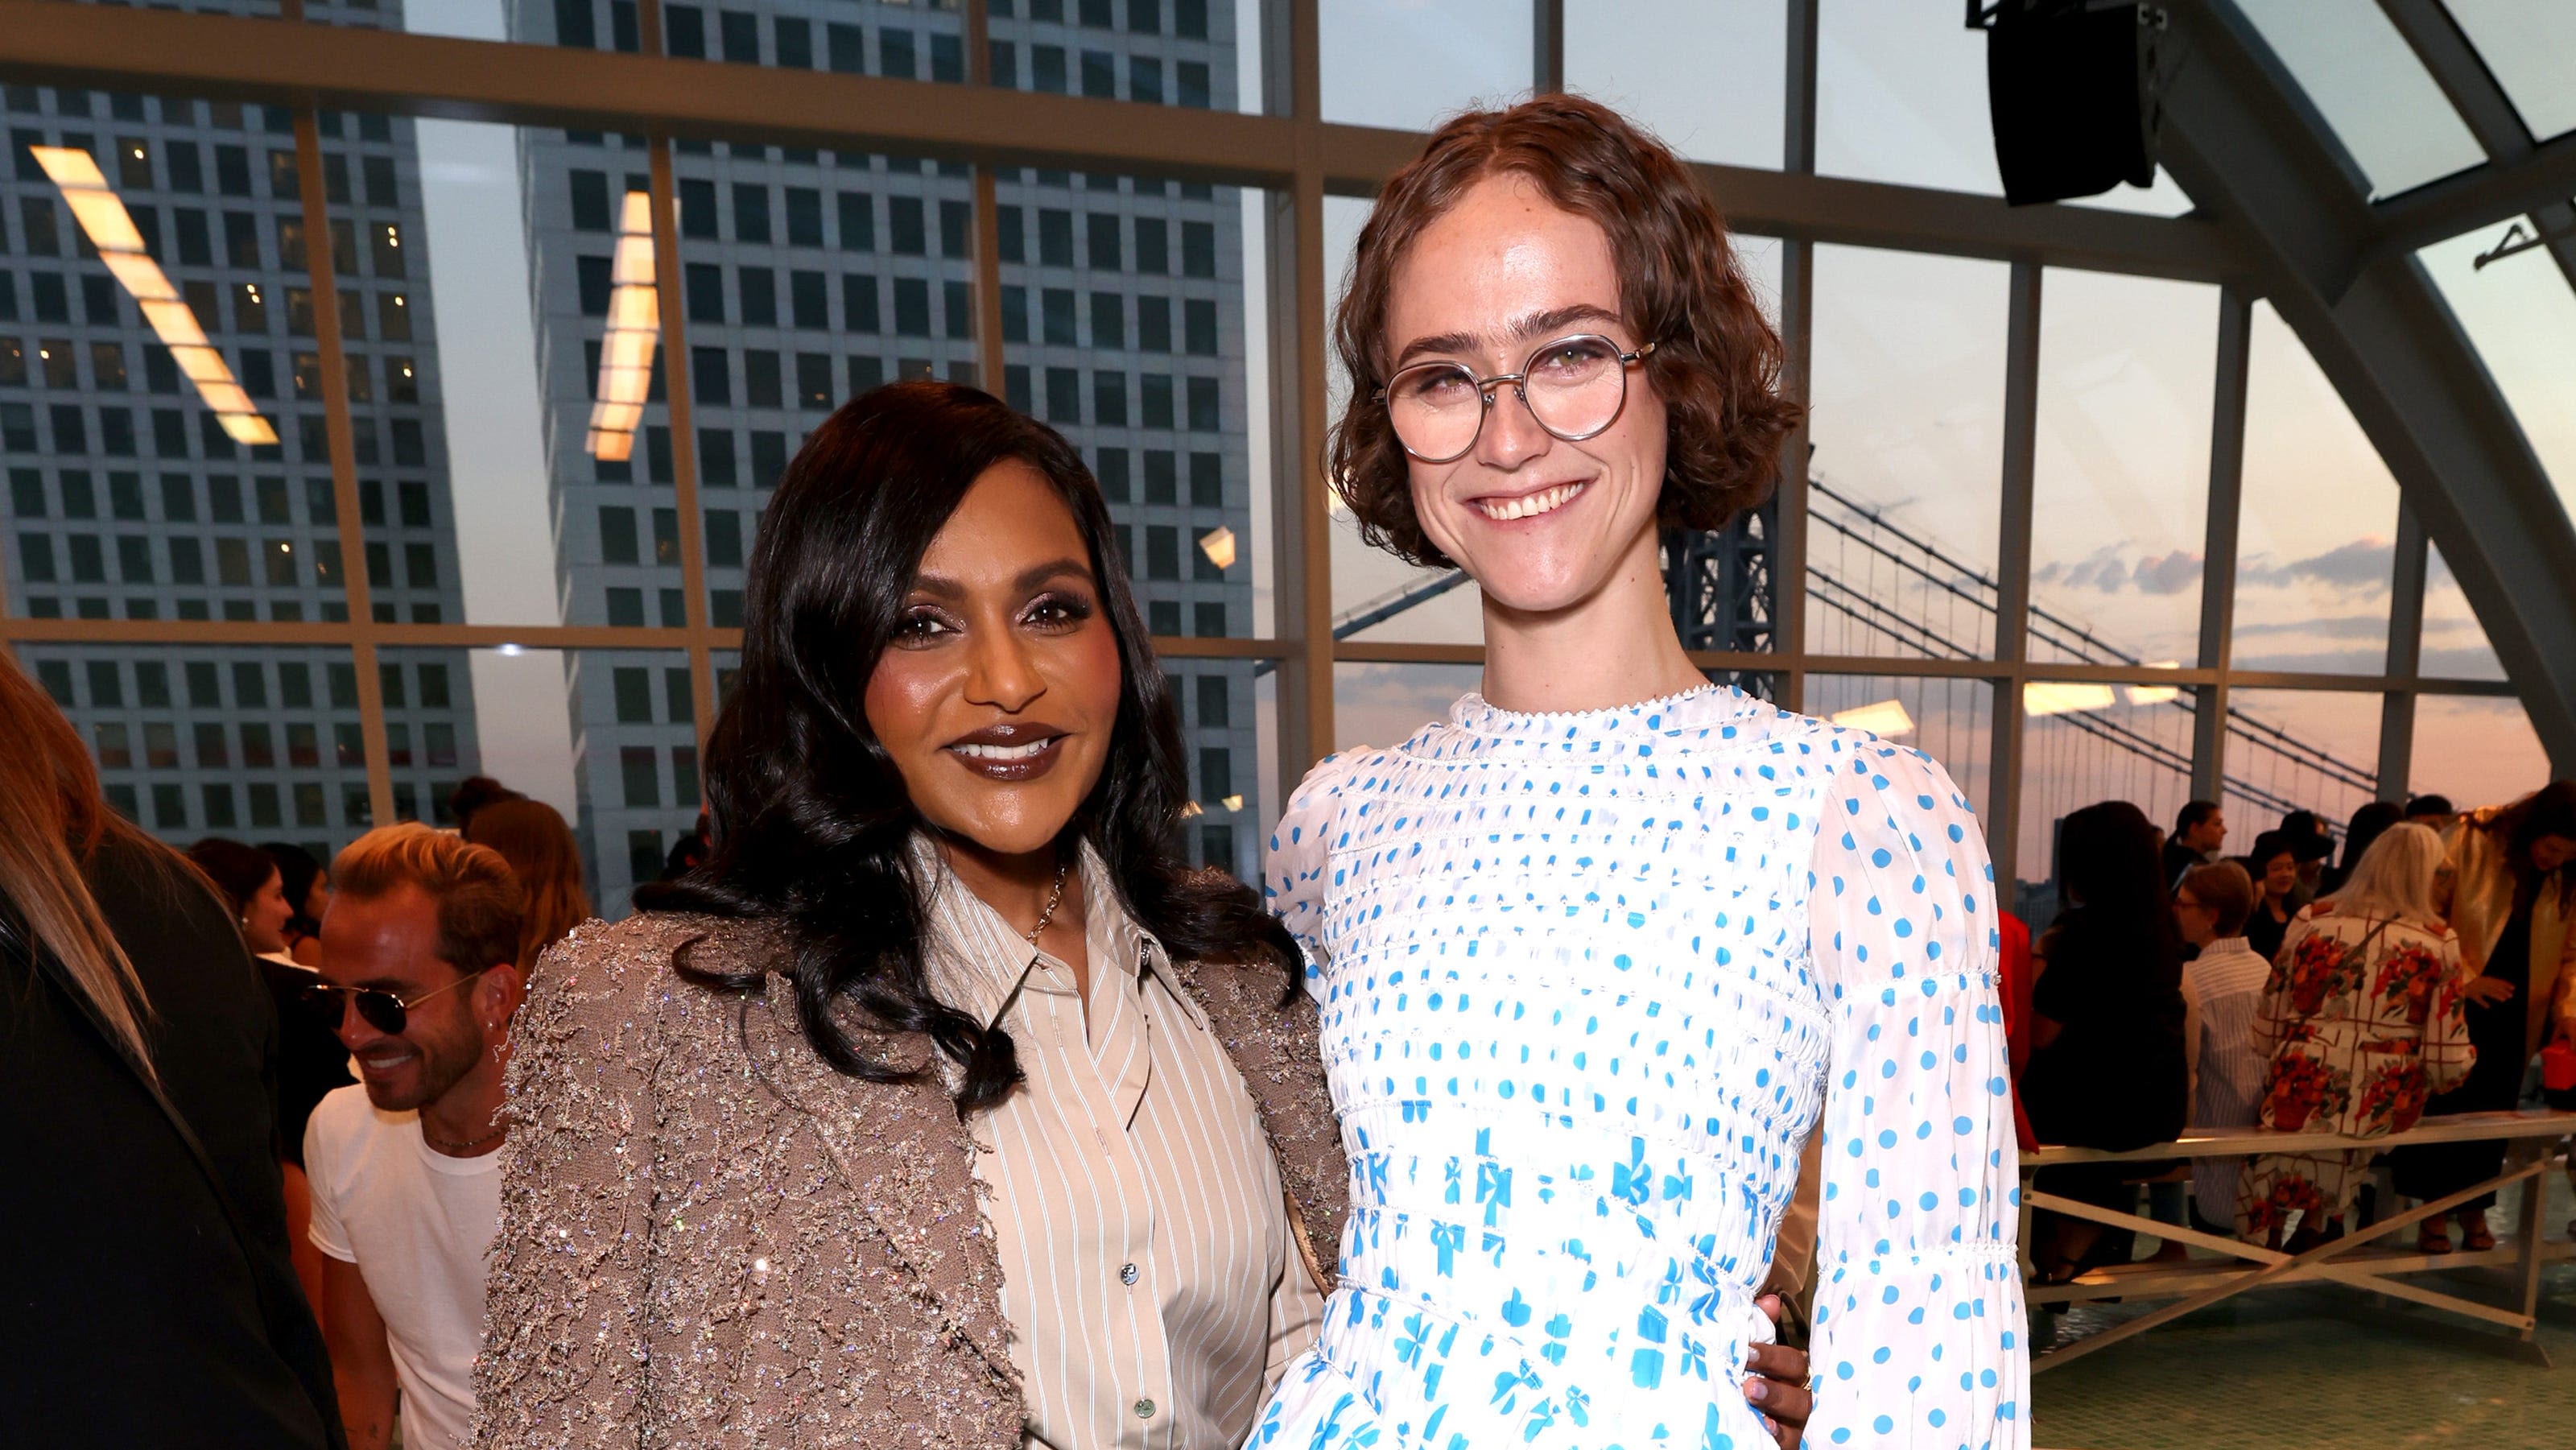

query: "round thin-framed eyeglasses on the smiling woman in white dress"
xmin=1378 ymin=333 xmax=1653 ymax=464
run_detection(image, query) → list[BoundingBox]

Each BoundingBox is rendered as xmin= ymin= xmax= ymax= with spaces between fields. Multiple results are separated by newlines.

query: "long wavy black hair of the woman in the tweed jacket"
xmin=636 ymin=381 xmax=1301 ymax=1113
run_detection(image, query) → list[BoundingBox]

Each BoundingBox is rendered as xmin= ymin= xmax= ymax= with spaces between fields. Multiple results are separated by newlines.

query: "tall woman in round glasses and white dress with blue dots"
xmin=1257 ymin=95 xmax=2027 ymax=1450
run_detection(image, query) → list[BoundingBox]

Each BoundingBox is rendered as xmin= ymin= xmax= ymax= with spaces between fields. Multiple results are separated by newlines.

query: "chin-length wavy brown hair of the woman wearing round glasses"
xmin=1324 ymin=95 xmax=1798 ymax=567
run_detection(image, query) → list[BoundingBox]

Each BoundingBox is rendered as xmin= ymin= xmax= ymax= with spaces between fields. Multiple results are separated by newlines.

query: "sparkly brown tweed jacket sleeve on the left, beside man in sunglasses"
xmin=474 ymin=922 xmax=667 ymax=1450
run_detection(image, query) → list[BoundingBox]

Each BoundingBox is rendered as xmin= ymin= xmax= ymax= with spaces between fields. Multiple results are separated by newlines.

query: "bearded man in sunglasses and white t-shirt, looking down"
xmin=304 ymin=824 xmax=526 ymax=1450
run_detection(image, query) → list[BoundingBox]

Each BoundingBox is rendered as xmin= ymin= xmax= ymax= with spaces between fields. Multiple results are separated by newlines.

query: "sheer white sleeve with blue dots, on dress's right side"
xmin=1806 ymin=734 xmax=2030 ymax=1450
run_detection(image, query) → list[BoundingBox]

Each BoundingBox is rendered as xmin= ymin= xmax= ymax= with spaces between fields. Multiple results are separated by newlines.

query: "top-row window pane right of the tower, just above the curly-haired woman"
xmin=1319 ymin=0 xmax=1533 ymax=131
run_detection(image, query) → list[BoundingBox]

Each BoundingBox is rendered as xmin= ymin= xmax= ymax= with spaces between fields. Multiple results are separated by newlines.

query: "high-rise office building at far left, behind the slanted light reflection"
xmin=0 ymin=0 xmax=477 ymax=853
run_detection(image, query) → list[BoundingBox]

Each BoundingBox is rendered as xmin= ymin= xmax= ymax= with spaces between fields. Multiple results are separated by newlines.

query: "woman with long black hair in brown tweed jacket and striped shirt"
xmin=477 ymin=384 xmax=1813 ymax=1450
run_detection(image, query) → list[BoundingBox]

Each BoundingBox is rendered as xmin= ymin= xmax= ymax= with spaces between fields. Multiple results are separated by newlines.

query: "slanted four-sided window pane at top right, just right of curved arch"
xmin=2239 ymin=0 xmax=2486 ymax=196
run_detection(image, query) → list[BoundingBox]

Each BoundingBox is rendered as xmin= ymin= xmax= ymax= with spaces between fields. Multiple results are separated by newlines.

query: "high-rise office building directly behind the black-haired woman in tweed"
xmin=510 ymin=0 xmax=1262 ymax=915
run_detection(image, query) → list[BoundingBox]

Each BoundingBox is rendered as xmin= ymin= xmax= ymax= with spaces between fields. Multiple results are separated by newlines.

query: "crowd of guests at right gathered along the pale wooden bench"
xmin=2004 ymin=780 xmax=2576 ymax=1283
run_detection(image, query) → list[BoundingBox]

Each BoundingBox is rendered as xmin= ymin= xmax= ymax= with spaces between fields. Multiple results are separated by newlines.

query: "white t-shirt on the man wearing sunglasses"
xmin=304 ymin=1087 xmax=500 ymax=1450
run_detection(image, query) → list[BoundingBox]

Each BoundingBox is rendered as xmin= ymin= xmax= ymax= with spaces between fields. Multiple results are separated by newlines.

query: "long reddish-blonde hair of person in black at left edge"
xmin=0 ymin=651 xmax=167 ymax=1079
